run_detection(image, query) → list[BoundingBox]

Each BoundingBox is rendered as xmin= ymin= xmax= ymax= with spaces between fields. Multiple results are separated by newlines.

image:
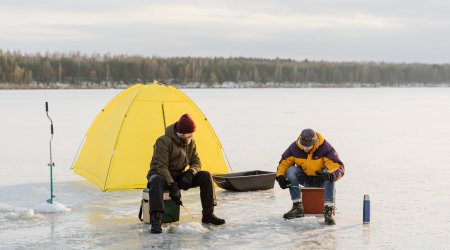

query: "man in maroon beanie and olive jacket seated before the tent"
xmin=147 ymin=114 xmax=225 ymax=233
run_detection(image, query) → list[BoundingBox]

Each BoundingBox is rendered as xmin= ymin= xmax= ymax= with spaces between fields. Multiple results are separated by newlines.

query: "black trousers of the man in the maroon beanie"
xmin=147 ymin=171 xmax=216 ymax=213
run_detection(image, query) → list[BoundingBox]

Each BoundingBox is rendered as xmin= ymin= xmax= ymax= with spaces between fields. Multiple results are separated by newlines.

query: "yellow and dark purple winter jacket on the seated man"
xmin=277 ymin=132 xmax=345 ymax=181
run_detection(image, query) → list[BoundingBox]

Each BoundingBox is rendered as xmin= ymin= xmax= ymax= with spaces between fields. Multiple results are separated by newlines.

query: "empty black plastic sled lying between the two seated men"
xmin=213 ymin=170 xmax=276 ymax=192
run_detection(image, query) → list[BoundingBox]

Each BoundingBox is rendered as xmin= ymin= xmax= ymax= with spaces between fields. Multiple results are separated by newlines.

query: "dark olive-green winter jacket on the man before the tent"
xmin=147 ymin=123 xmax=201 ymax=185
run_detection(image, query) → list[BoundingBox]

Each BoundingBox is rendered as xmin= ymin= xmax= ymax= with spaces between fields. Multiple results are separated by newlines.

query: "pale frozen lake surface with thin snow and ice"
xmin=0 ymin=88 xmax=450 ymax=249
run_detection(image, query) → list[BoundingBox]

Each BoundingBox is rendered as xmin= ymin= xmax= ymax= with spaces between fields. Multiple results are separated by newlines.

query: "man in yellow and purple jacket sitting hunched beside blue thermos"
xmin=276 ymin=129 xmax=345 ymax=225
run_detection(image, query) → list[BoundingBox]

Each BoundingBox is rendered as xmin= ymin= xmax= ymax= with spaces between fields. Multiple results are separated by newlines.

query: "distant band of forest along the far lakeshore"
xmin=0 ymin=50 xmax=450 ymax=88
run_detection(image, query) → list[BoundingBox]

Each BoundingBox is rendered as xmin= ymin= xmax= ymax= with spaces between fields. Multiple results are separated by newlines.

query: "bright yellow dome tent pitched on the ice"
xmin=73 ymin=83 xmax=229 ymax=191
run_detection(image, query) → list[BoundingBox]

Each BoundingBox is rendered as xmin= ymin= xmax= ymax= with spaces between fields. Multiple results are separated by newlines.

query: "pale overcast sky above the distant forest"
xmin=0 ymin=0 xmax=450 ymax=63
